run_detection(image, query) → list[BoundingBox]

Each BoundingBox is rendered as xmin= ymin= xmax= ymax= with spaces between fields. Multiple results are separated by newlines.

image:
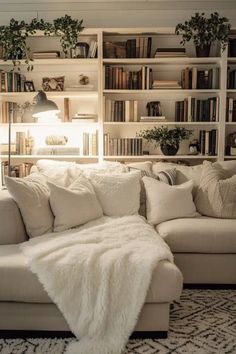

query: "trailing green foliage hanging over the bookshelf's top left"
xmin=0 ymin=15 xmax=84 ymax=70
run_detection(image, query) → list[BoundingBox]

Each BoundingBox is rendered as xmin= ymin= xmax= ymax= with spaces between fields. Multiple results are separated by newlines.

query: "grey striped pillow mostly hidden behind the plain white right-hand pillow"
xmin=129 ymin=167 xmax=176 ymax=218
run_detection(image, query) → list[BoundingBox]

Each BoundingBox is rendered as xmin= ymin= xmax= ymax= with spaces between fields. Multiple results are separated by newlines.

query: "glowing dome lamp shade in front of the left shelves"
xmin=32 ymin=91 xmax=60 ymax=118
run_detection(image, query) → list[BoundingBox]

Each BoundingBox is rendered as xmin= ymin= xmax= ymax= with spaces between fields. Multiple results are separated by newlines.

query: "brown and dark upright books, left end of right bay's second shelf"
xmin=105 ymin=65 xmax=153 ymax=90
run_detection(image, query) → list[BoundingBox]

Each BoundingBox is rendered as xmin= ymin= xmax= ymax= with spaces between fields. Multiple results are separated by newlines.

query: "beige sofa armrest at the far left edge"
xmin=0 ymin=190 xmax=28 ymax=245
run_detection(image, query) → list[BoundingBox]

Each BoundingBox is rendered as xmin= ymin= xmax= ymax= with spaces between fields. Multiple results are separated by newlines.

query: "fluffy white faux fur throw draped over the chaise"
xmin=21 ymin=216 xmax=173 ymax=354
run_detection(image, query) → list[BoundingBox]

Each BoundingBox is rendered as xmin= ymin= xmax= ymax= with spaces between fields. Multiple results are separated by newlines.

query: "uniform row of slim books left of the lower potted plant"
xmin=104 ymin=133 xmax=143 ymax=156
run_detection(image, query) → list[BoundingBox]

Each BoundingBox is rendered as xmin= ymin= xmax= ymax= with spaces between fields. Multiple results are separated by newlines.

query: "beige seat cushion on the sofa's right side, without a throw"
xmin=156 ymin=216 xmax=236 ymax=253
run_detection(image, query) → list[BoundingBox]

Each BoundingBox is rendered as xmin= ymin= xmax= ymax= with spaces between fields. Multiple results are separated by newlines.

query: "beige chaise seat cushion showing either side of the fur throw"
xmin=0 ymin=245 xmax=183 ymax=303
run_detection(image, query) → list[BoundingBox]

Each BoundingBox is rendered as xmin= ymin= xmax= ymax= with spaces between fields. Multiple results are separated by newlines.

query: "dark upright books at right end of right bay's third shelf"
xmin=175 ymin=96 xmax=219 ymax=122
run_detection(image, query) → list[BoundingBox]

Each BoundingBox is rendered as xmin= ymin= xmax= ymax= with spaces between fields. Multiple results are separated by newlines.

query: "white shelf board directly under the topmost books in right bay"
xmin=103 ymin=57 xmax=221 ymax=65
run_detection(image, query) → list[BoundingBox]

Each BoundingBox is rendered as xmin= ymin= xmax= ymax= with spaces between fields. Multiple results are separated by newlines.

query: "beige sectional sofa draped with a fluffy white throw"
xmin=0 ymin=162 xmax=236 ymax=332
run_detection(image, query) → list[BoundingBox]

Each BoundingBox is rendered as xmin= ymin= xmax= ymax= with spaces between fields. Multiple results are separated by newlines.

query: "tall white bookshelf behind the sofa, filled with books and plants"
xmin=0 ymin=27 xmax=236 ymax=184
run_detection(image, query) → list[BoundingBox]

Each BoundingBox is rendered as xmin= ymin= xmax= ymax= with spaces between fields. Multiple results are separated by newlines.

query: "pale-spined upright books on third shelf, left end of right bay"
xmin=105 ymin=99 xmax=138 ymax=122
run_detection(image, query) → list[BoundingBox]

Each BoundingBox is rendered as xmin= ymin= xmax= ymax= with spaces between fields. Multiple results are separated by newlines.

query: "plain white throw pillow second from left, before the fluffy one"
xmin=48 ymin=175 xmax=103 ymax=231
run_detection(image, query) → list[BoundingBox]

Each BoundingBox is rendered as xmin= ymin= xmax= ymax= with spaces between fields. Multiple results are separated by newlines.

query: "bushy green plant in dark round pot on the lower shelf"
xmin=139 ymin=126 xmax=192 ymax=155
